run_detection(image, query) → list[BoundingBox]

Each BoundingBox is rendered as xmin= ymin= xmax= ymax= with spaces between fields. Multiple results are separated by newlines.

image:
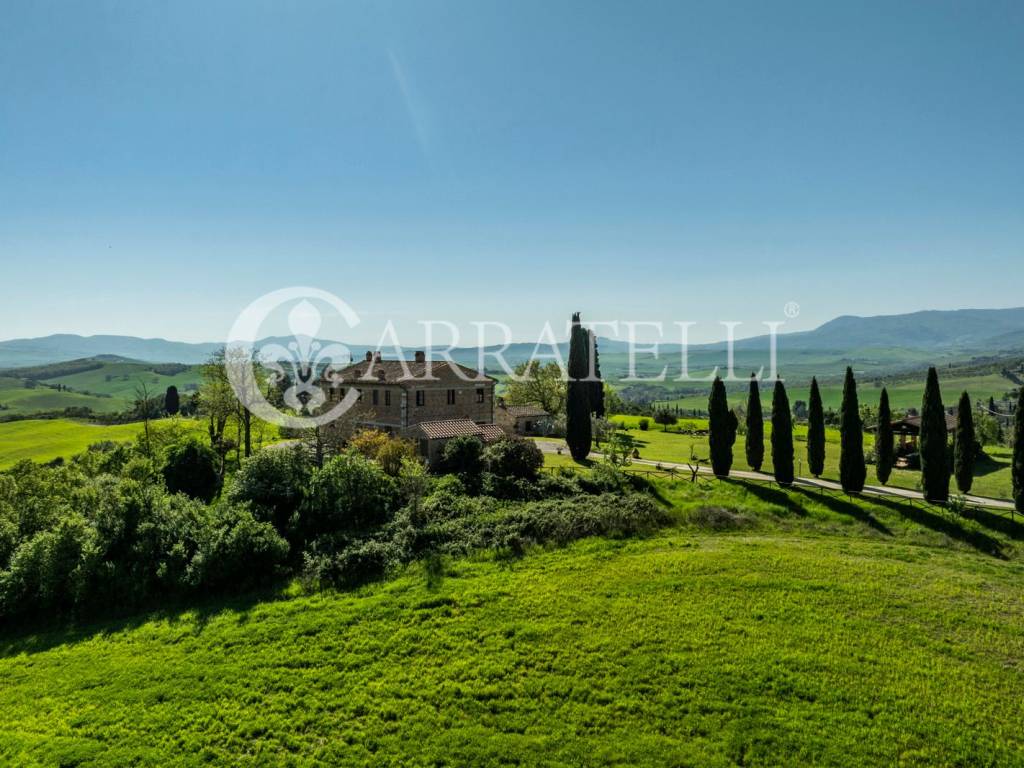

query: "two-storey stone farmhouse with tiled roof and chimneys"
xmin=321 ymin=352 xmax=505 ymax=462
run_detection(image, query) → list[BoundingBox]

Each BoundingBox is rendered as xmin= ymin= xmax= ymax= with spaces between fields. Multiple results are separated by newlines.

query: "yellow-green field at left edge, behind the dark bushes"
xmin=0 ymin=419 xmax=204 ymax=469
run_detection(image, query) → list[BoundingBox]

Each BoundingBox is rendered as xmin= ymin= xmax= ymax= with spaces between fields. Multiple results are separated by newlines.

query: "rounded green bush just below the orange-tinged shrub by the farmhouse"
xmin=301 ymin=453 xmax=398 ymax=541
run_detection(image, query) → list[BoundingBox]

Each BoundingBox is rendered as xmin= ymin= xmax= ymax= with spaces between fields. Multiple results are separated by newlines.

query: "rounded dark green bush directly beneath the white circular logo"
xmin=227 ymin=446 xmax=311 ymax=536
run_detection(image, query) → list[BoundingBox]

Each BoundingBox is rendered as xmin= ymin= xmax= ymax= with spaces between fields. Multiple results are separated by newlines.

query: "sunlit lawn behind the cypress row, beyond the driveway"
xmin=598 ymin=416 xmax=1013 ymax=499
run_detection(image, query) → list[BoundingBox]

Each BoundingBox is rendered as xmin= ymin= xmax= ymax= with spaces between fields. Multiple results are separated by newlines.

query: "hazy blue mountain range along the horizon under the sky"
xmin=0 ymin=307 xmax=1024 ymax=369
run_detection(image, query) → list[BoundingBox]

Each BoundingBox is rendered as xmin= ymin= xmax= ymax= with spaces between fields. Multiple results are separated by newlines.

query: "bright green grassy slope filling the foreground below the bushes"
xmin=0 ymin=480 xmax=1024 ymax=766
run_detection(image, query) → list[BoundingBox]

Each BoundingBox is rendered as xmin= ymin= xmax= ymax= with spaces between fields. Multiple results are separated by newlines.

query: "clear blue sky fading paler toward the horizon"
xmin=0 ymin=0 xmax=1024 ymax=341
